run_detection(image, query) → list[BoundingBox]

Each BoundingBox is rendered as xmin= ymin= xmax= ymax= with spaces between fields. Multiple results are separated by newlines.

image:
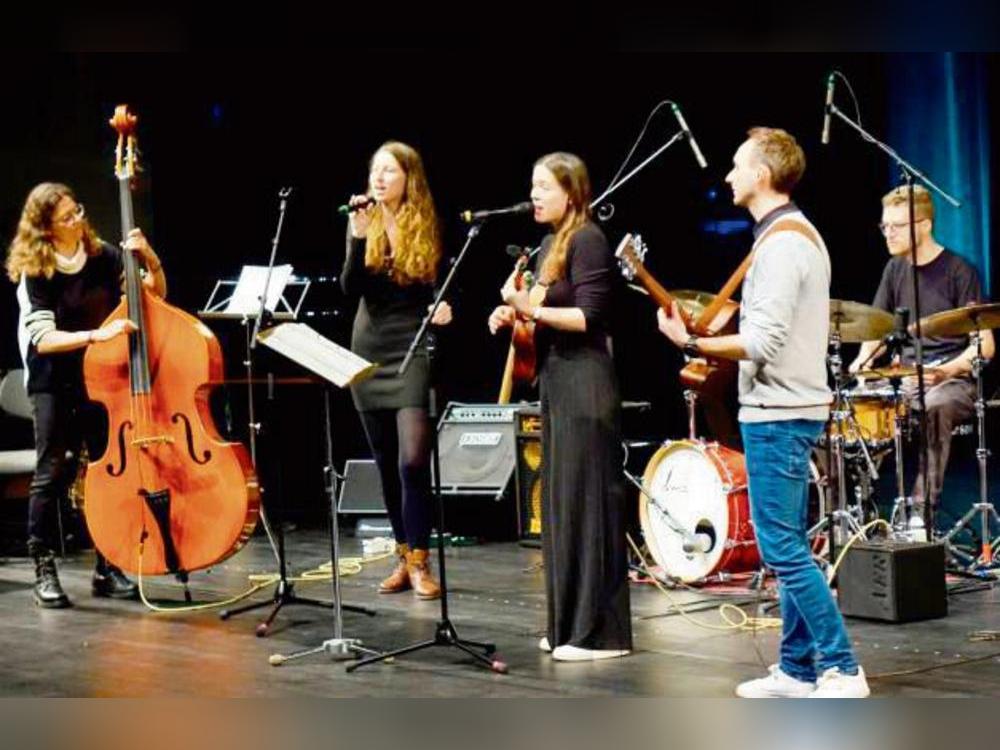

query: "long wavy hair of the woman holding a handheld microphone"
xmin=365 ymin=141 xmax=441 ymax=286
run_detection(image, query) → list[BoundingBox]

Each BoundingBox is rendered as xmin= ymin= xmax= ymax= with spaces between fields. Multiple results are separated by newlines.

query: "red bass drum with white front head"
xmin=639 ymin=440 xmax=825 ymax=583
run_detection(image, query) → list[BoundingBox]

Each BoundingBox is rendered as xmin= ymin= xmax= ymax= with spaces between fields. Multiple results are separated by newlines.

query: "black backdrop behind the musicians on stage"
xmin=0 ymin=53 xmax=997 ymax=524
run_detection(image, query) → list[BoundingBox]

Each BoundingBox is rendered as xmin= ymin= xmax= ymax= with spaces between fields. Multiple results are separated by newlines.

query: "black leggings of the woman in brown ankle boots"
xmin=361 ymin=407 xmax=431 ymax=549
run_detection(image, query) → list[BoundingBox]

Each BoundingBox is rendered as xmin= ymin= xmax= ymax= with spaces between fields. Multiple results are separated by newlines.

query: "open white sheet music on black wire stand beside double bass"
xmin=198 ymin=264 xmax=312 ymax=320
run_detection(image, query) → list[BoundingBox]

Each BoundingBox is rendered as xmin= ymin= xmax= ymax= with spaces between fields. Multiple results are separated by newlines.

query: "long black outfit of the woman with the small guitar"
xmin=536 ymin=223 xmax=632 ymax=649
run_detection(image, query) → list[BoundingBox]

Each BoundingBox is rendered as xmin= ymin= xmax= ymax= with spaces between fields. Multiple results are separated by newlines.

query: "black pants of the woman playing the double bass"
xmin=28 ymin=391 xmax=108 ymax=552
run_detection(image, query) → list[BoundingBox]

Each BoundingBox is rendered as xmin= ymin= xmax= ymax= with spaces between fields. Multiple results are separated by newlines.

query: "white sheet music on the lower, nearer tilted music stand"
xmin=257 ymin=323 xmax=378 ymax=388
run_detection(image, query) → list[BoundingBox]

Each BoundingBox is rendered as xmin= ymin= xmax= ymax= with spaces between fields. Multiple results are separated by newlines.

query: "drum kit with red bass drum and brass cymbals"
xmin=629 ymin=291 xmax=1000 ymax=584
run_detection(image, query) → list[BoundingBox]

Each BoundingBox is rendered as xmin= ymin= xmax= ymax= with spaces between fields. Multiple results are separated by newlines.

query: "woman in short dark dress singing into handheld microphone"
xmin=341 ymin=141 xmax=451 ymax=599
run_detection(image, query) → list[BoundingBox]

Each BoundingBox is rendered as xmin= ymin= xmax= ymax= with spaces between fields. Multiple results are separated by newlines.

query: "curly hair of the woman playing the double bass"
xmin=7 ymin=182 xmax=101 ymax=283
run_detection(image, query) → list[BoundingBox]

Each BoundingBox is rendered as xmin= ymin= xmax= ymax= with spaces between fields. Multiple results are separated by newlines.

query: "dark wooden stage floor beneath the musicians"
xmin=0 ymin=529 xmax=1000 ymax=697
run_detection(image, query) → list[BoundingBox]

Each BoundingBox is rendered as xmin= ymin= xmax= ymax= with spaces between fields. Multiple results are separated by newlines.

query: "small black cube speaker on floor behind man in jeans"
xmin=837 ymin=541 xmax=948 ymax=622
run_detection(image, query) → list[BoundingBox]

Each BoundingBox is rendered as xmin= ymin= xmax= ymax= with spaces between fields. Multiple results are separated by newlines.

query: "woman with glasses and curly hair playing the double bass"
xmin=7 ymin=182 xmax=167 ymax=608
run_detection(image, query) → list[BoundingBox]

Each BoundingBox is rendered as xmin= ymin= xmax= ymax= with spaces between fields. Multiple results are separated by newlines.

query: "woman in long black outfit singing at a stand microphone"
xmin=489 ymin=153 xmax=632 ymax=661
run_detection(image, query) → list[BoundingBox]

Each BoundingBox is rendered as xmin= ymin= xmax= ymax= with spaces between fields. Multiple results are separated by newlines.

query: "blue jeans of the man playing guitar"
xmin=740 ymin=419 xmax=858 ymax=682
